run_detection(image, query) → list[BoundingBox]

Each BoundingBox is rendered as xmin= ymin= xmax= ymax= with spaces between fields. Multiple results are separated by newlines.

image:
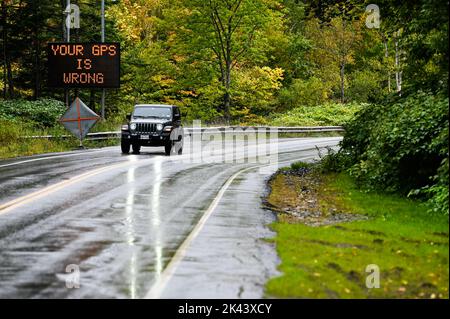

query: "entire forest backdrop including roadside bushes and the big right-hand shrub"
xmin=0 ymin=0 xmax=448 ymax=214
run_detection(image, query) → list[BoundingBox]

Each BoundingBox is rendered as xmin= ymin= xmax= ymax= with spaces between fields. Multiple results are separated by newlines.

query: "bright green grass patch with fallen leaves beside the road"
xmin=266 ymin=174 xmax=449 ymax=298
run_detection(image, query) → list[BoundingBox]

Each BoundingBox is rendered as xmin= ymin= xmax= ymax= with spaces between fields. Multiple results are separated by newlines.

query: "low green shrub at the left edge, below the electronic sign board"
xmin=0 ymin=99 xmax=65 ymax=127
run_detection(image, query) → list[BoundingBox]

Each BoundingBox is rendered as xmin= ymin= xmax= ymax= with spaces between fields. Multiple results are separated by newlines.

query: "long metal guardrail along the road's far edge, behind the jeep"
xmin=25 ymin=126 xmax=344 ymax=141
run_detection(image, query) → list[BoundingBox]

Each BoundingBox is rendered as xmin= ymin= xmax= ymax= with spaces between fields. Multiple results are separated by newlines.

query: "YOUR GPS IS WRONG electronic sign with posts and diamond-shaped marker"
xmin=51 ymin=0 xmax=120 ymax=148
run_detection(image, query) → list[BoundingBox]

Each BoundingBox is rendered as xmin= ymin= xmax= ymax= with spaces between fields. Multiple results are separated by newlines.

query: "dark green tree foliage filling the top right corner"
xmin=378 ymin=0 xmax=449 ymax=94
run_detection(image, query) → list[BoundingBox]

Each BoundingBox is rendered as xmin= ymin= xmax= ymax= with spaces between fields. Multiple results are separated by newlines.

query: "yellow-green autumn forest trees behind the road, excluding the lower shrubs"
xmin=0 ymin=0 xmax=448 ymax=122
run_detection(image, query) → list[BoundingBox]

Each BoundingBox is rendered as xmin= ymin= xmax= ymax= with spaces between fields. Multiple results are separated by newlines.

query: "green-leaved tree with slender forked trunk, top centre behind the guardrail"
xmin=175 ymin=0 xmax=279 ymax=121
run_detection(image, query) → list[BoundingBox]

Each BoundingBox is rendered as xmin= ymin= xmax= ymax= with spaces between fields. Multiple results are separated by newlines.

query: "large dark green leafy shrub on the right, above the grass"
xmin=330 ymin=92 xmax=449 ymax=211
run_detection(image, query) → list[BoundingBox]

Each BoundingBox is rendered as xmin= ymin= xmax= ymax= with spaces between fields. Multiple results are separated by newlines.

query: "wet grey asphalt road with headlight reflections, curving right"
xmin=0 ymin=137 xmax=340 ymax=298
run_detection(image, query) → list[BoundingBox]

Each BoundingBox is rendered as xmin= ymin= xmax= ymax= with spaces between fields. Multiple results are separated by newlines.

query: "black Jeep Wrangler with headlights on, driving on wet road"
xmin=121 ymin=104 xmax=184 ymax=155
